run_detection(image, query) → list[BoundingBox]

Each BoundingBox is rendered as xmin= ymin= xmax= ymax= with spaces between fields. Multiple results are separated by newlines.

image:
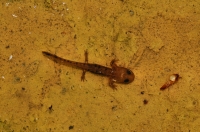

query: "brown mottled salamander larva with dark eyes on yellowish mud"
xmin=42 ymin=51 xmax=135 ymax=89
